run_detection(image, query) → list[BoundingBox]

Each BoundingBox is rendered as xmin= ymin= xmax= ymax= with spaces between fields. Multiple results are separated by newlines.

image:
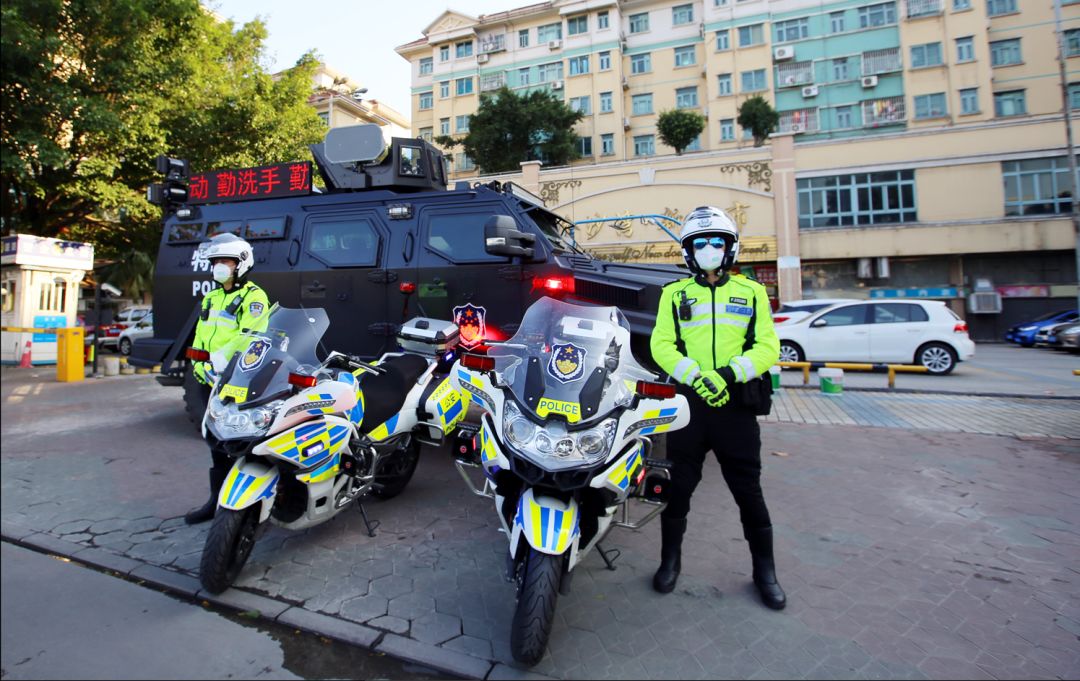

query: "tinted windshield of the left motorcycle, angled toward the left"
xmin=211 ymin=304 xmax=330 ymax=409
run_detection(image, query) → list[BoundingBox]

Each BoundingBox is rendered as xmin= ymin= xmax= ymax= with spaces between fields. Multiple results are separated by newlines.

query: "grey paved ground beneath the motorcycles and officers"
xmin=0 ymin=376 xmax=1080 ymax=679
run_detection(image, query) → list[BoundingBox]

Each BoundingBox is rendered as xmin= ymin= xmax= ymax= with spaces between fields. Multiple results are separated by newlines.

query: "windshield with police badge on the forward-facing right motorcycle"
xmin=487 ymin=298 xmax=656 ymax=424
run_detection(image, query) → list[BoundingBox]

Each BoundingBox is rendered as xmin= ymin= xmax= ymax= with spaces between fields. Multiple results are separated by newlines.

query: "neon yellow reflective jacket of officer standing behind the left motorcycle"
xmin=193 ymin=282 xmax=270 ymax=383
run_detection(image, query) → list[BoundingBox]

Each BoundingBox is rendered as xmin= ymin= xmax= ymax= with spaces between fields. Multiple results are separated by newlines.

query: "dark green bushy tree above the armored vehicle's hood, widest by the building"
xmin=435 ymin=86 xmax=583 ymax=173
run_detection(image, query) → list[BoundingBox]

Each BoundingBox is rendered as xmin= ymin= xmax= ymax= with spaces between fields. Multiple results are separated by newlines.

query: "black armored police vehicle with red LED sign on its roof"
xmin=130 ymin=125 xmax=686 ymax=417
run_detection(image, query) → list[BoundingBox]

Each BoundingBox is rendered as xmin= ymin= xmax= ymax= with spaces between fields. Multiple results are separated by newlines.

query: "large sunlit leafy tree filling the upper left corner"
xmin=0 ymin=0 xmax=323 ymax=263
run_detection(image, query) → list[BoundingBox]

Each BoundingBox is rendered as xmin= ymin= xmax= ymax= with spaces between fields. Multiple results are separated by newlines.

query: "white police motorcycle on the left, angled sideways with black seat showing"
xmin=189 ymin=304 xmax=465 ymax=594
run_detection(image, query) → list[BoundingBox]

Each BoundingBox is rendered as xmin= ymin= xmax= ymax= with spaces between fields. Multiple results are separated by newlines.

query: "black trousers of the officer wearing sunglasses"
xmin=663 ymin=385 xmax=772 ymax=529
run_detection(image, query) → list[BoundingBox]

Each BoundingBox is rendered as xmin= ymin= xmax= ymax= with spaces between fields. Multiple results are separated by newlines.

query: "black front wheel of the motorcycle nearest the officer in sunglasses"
xmin=510 ymin=546 xmax=564 ymax=667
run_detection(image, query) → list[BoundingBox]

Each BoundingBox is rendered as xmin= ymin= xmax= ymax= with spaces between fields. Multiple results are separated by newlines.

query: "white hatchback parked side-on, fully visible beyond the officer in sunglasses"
xmin=777 ymin=300 xmax=975 ymax=376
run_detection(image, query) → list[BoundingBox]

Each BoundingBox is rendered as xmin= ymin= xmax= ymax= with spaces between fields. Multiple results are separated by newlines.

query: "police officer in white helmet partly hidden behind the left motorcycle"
xmin=184 ymin=233 xmax=270 ymax=525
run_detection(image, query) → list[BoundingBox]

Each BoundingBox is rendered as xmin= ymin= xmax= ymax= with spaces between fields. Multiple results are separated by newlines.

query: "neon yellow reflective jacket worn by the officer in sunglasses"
xmin=650 ymin=274 xmax=780 ymax=384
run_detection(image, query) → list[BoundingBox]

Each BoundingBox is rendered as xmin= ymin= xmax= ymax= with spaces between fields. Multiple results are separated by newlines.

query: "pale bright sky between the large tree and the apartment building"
xmin=204 ymin=0 xmax=518 ymax=117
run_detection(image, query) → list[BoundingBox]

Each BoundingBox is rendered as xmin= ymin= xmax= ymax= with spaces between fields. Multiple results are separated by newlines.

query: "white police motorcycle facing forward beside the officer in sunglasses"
xmin=451 ymin=298 xmax=690 ymax=665
